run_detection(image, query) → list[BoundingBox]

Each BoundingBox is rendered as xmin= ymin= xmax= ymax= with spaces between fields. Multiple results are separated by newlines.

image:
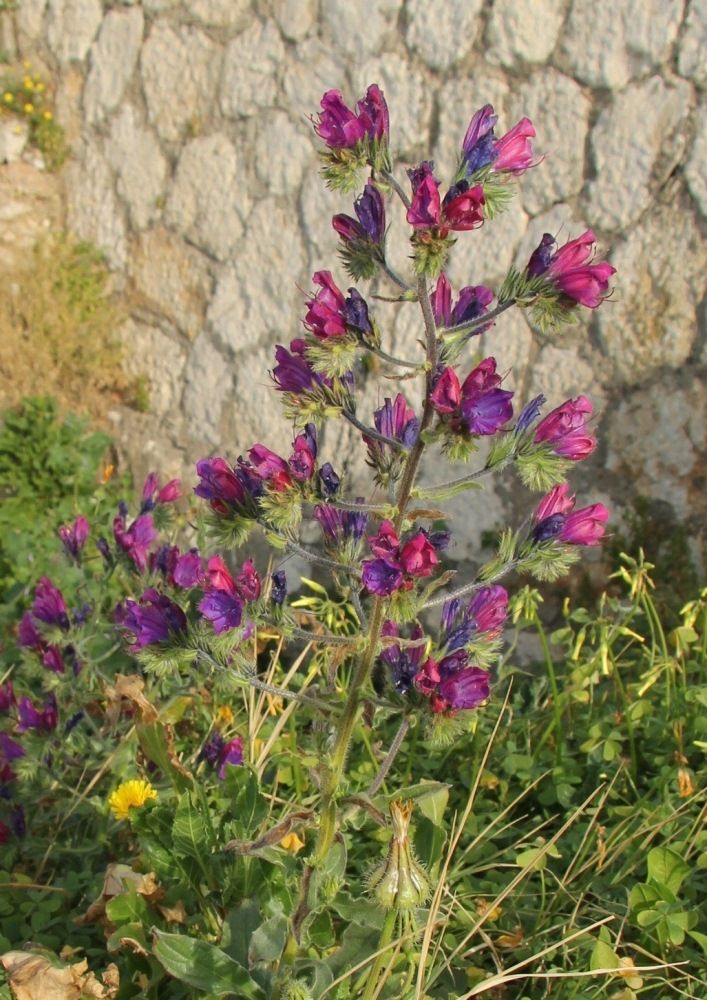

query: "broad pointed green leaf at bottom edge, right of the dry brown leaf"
xmin=152 ymin=928 xmax=265 ymax=1000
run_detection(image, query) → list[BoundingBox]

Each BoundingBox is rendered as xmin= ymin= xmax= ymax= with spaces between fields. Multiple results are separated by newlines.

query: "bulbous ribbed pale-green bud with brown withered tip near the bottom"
xmin=369 ymin=799 xmax=430 ymax=910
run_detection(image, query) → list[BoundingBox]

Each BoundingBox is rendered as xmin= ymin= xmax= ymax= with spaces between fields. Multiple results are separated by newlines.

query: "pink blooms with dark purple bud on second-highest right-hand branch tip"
xmin=526 ymin=229 xmax=616 ymax=309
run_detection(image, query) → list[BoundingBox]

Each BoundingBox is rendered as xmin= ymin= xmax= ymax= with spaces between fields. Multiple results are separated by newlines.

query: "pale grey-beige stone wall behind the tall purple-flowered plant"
xmin=0 ymin=0 xmax=707 ymax=557
